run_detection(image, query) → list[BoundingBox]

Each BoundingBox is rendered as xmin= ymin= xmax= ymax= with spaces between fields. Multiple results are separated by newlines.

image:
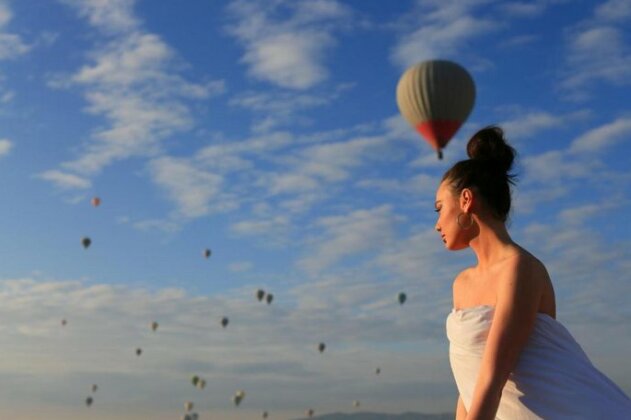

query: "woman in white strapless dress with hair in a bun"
xmin=436 ymin=127 xmax=631 ymax=420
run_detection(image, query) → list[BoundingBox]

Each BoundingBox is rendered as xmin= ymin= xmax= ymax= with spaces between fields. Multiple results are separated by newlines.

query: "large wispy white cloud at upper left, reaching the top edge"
xmin=43 ymin=0 xmax=223 ymax=185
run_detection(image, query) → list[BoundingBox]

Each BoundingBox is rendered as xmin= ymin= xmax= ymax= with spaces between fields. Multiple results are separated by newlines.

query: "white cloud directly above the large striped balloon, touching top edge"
xmin=391 ymin=0 xmax=500 ymax=68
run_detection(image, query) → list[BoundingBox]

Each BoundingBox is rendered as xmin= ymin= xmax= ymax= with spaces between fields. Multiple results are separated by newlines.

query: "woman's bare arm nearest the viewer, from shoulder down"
xmin=466 ymin=256 xmax=545 ymax=420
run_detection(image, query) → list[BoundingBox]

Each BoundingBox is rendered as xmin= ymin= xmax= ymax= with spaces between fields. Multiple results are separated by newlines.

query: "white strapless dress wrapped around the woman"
xmin=447 ymin=306 xmax=631 ymax=420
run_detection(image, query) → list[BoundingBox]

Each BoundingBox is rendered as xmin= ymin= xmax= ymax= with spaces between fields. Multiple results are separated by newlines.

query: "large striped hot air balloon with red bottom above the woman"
xmin=397 ymin=60 xmax=475 ymax=159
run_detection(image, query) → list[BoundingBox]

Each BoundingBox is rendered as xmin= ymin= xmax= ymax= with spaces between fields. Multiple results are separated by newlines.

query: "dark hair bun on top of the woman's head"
xmin=467 ymin=125 xmax=516 ymax=173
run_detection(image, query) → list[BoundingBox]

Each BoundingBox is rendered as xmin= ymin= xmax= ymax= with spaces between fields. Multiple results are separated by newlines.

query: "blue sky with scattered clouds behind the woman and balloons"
xmin=0 ymin=0 xmax=631 ymax=419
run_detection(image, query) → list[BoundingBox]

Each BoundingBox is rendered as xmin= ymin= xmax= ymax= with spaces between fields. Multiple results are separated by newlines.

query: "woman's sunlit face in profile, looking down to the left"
xmin=434 ymin=181 xmax=469 ymax=251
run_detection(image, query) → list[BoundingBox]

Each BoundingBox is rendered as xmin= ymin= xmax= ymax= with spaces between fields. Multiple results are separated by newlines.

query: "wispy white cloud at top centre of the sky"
xmin=227 ymin=0 xmax=351 ymax=89
